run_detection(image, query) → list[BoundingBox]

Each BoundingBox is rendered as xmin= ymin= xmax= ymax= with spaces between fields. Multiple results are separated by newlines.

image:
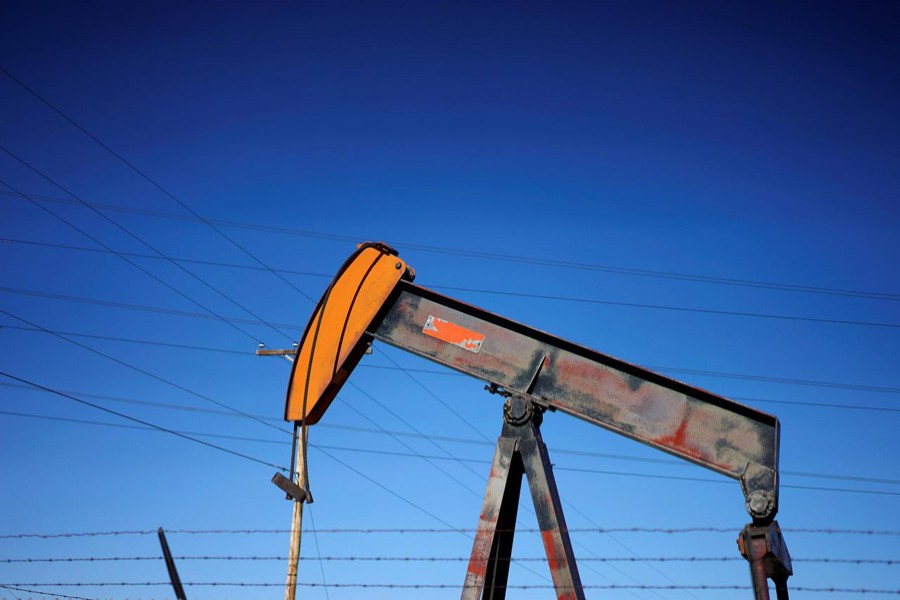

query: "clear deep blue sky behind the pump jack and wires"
xmin=0 ymin=1 xmax=900 ymax=600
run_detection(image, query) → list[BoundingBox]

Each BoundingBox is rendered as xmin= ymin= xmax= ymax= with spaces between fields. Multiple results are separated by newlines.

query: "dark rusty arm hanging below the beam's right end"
xmin=738 ymin=521 xmax=794 ymax=600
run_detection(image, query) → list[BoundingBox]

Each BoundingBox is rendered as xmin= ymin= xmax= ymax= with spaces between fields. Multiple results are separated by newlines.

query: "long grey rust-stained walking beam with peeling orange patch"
xmin=368 ymin=281 xmax=779 ymax=525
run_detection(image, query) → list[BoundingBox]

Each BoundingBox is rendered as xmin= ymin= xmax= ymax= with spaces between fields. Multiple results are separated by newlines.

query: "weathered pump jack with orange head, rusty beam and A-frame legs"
xmin=284 ymin=243 xmax=793 ymax=600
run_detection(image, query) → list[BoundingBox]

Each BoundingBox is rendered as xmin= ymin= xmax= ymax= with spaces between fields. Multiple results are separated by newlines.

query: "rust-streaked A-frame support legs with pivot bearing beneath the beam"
xmin=461 ymin=396 xmax=584 ymax=600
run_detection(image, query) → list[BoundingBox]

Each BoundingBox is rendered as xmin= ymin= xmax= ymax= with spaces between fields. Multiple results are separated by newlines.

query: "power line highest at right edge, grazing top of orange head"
xmin=0 ymin=192 xmax=900 ymax=301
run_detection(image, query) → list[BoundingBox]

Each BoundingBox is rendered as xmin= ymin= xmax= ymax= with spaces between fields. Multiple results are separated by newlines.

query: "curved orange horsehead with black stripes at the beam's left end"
xmin=284 ymin=244 xmax=407 ymax=425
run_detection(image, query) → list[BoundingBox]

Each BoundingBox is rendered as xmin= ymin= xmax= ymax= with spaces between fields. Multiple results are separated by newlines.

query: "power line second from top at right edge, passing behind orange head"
xmin=4 ymin=238 xmax=900 ymax=328
